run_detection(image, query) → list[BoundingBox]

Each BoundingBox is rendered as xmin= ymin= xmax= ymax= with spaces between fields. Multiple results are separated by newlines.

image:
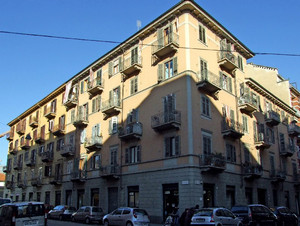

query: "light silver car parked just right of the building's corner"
xmin=191 ymin=207 xmax=242 ymax=226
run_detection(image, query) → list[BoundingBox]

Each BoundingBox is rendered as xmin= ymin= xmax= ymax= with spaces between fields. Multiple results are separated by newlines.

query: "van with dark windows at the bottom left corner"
xmin=0 ymin=202 xmax=47 ymax=226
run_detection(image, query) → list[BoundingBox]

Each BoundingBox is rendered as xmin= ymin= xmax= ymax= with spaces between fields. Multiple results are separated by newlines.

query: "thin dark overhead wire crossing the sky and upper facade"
xmin=0 ymin=30 xmax=300 ymax=57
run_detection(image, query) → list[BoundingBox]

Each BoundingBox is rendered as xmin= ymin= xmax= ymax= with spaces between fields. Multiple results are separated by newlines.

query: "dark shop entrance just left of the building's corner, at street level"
xmin=163 ymin=184 xmax=179 ymax=219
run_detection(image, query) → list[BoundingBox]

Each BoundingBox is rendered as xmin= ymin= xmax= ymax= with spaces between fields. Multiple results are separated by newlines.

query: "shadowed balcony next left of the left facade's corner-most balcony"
xmin=119 ymin=122 xmax=143 ymax=141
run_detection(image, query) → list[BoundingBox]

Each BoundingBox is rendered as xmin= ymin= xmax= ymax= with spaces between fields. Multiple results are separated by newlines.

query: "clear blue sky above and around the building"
xmin=0 ymin=0 xmax=300 ymax=165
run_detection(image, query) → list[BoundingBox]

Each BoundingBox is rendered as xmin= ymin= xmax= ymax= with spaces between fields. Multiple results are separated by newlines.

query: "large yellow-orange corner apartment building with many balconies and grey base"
xmin=5 ymin=0 xmax=300 ymax=223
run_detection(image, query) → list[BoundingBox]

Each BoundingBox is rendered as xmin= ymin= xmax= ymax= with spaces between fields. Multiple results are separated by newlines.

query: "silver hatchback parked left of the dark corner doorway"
xmin=103 ymin=207 xmax=150 ymax=226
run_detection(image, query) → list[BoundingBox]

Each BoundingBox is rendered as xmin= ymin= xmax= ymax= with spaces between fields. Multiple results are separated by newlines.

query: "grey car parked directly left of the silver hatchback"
xmin=71 ymin=206 xmax=104 ymax=224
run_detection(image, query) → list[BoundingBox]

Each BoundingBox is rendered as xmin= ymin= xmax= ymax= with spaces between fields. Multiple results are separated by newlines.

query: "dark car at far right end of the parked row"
xmin=274 ymin=206 xmax=298 ymax=226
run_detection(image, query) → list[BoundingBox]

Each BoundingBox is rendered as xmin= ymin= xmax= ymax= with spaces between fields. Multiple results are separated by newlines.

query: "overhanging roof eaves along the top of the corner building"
xmin=7 ymin=0 xmax=255 ymax=127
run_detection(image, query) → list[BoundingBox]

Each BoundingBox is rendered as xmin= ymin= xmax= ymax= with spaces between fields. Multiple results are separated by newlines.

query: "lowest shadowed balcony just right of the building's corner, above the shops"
xmin=200 ymin=153 xmax=226 ymax=174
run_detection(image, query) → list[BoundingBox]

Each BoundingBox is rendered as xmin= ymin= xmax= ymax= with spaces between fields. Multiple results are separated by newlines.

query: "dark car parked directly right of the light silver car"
xmin=231 ymin=204 xmax=277 ymax=226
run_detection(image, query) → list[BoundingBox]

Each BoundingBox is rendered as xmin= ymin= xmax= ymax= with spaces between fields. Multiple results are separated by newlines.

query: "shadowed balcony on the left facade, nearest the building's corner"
xmin=151 ymin=110 xmax=181 ymax=132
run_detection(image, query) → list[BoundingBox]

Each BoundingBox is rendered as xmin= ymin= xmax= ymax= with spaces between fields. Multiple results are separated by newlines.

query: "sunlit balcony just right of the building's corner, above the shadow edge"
xmin=197 ymin=70 xmax=221 ymax=96
